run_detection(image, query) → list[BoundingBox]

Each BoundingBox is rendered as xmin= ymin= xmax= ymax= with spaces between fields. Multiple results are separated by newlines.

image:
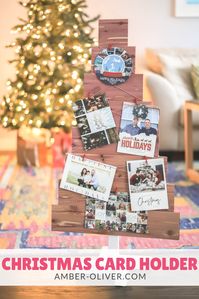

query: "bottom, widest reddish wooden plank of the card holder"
xmin=52 ymin=199 xmax=180 ymax=239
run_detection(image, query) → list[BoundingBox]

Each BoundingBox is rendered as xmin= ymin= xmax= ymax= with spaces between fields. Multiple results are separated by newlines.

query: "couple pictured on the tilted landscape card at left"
xmin=77 ymin=167 xmax=99 ymax=190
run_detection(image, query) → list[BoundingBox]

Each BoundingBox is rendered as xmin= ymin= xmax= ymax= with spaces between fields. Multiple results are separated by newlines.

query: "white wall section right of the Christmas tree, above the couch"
xmin=87 ymin=0 xmax=199 ymax=71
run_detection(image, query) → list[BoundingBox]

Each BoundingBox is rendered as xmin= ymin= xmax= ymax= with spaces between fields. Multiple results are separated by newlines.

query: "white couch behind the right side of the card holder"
xmin=145 ymin=49 xmax=199 ymax=151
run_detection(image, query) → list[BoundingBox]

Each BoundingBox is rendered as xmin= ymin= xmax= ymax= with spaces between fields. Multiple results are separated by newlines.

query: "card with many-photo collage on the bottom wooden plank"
xmin=85 ymin=192 xmax=148 ymax=234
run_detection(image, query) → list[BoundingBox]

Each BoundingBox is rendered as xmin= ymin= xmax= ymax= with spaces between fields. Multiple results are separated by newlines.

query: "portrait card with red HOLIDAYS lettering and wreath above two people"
xmin=117 ymin=102 xmax=159 ymax=157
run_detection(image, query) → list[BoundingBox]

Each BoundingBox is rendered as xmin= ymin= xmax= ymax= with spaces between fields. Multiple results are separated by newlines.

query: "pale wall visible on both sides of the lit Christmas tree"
xmin=0 ymin=0 xmax=199 ymax=148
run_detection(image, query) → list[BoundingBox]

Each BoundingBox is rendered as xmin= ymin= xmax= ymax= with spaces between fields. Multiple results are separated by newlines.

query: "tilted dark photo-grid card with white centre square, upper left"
xmin=73 ymin=94 xmax=118 ymax=151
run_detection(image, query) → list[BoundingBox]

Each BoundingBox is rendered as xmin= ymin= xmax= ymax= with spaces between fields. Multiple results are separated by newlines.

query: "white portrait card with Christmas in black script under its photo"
xmin=127 ymin=158 xmax=168 ymax=211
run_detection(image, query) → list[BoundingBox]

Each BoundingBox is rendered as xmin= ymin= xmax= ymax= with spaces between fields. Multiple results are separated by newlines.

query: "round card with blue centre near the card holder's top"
xmin=94 ymin=47 xmax=134 ymax=85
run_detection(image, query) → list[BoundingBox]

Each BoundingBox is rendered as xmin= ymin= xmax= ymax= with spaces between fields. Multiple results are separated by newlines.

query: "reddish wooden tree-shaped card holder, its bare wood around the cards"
xmin=52 ymin=20 xmax=180 ymax=239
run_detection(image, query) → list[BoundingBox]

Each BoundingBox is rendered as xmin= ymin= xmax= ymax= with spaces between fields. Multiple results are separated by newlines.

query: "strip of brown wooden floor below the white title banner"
xmin=0 ymin=287 xmax=199 ymax=299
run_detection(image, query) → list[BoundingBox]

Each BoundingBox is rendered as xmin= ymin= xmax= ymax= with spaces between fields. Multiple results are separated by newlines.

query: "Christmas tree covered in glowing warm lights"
xmin=0 ymin=0 xmax=96 ymax=131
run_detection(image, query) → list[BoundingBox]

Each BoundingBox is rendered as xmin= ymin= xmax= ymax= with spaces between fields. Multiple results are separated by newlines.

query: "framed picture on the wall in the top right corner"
xmin=175 ymin=0 xmax=199 ymax=17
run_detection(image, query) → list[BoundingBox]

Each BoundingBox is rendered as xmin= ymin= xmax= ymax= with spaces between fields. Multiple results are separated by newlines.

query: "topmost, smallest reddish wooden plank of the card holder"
xmin=98 ymin=19 xmax=128 ymax=47
